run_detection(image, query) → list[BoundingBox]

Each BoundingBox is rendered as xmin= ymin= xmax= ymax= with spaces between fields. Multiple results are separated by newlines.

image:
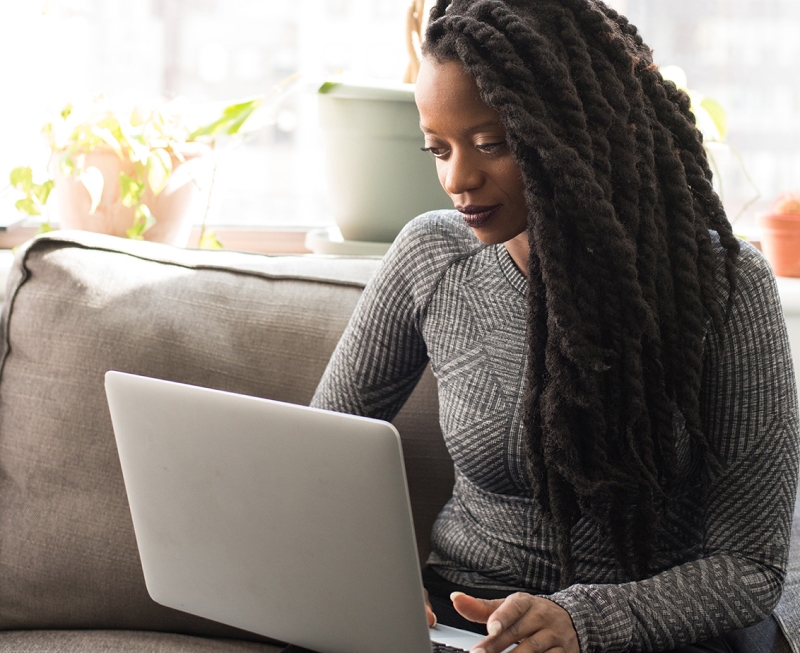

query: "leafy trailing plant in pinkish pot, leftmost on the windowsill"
xmin=10 ymin=96 xmax=263 ymax=247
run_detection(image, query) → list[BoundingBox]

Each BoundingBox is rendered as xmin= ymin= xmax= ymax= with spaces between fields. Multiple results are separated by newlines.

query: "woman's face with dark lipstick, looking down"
xmin=415 ymin=57 xmax=528 ymax=244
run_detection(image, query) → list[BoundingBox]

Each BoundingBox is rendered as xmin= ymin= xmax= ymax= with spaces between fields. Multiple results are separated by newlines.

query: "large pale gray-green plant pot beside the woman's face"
xmin=319 ymin=82 xmax=453 ymax=243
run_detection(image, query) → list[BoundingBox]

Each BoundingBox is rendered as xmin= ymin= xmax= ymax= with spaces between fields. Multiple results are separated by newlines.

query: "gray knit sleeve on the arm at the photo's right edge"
xmin=548 ymin=246 xmax=798 ymax=653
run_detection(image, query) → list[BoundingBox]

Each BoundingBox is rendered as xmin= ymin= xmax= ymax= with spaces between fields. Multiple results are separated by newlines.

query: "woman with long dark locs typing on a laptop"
xmin=313 ymin=0 xmax=798 ymax=653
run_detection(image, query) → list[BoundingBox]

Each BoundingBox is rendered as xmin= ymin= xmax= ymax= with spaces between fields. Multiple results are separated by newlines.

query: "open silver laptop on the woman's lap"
xmin=105 ymin=372 xmax=488 ymax=653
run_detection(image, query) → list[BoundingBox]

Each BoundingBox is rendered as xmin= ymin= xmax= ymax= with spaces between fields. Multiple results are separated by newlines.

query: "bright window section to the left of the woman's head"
xmin=0 ymin=0 xmax=407 ymax=232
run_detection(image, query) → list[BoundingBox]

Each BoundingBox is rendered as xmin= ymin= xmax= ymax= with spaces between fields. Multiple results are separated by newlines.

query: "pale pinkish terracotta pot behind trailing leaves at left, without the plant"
xmin=54 ymin=144 xmax=210 ymax=247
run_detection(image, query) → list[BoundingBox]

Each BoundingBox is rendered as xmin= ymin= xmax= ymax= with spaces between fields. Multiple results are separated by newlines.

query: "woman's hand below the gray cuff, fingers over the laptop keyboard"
xmin=450 ymin=592 xmax=580 ymax=653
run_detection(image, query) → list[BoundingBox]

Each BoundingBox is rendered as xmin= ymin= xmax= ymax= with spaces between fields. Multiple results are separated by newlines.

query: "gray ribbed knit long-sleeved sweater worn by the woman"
xmin=312 ymin=211 xmax=798 ymax=653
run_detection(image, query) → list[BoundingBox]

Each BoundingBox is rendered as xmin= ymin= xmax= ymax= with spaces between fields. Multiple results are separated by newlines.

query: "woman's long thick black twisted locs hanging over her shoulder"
xmin=423 ymin=0 xmax=739 ymax=584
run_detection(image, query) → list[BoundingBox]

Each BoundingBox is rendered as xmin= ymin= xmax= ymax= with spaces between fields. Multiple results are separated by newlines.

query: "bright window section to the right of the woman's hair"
xmin=615 ymin=0 xmax=800 ymax=234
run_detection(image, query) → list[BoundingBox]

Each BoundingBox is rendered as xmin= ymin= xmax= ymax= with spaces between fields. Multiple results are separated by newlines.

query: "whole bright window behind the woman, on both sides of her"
xmin=0 ymin=0 xmax=800 ymax=230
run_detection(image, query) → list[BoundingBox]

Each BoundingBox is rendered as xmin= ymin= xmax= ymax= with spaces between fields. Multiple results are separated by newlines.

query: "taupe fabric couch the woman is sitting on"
xmin=0 ymin=232 xmax=800 ymax=653
